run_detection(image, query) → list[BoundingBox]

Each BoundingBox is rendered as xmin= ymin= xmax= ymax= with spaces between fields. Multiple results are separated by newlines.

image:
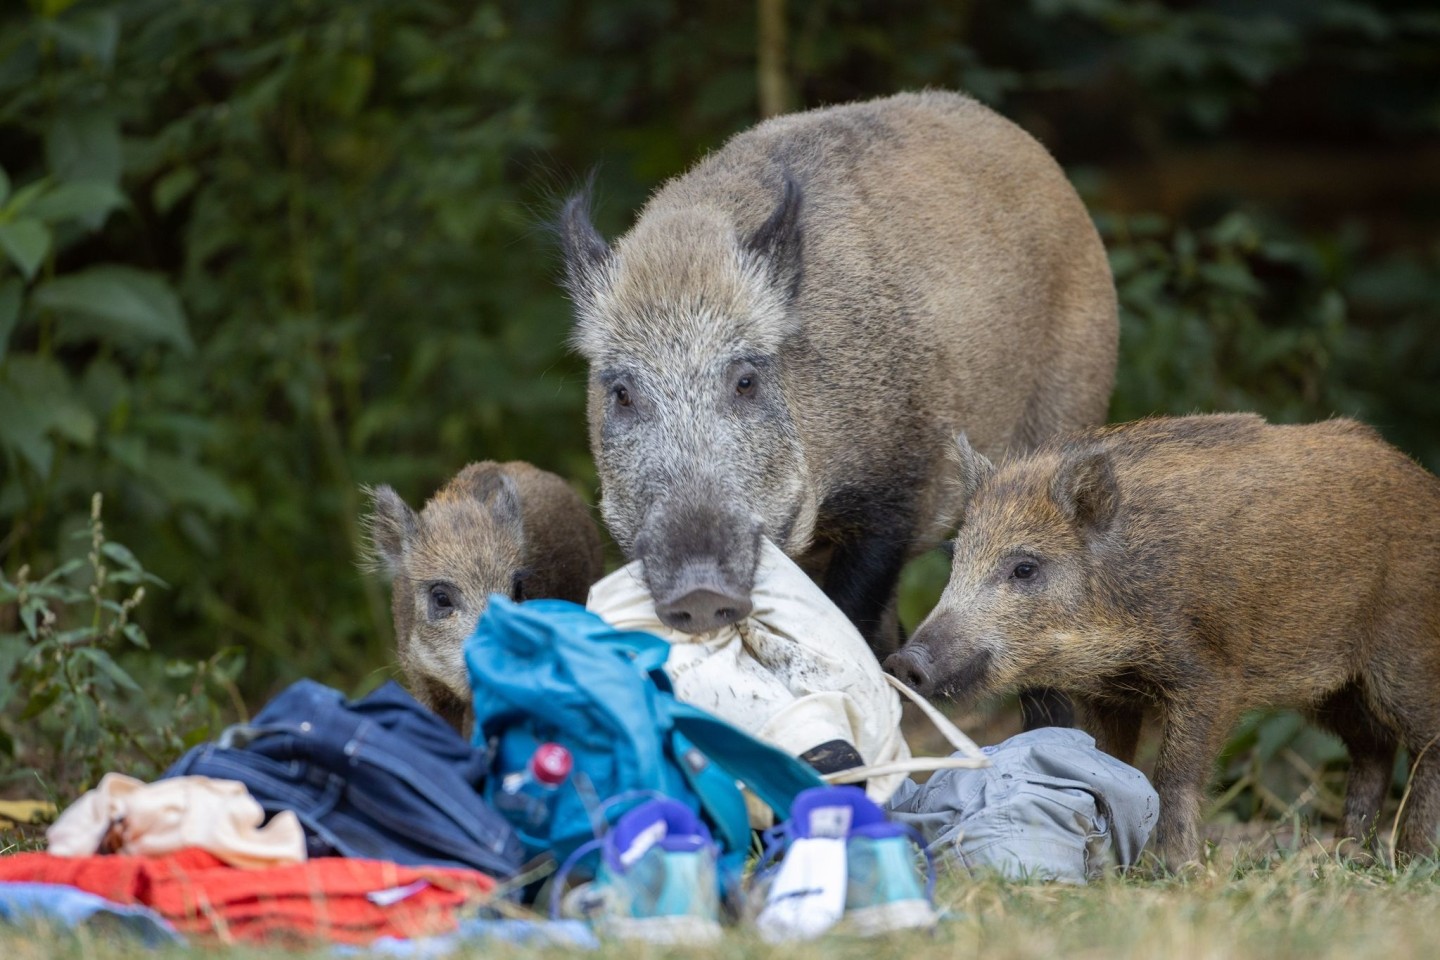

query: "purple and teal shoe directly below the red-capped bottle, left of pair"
xmin=552 ymin=799 xmax=720 ymax=944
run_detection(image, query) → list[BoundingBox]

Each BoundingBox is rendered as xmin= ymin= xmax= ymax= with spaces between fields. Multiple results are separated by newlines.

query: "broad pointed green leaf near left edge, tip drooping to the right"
xmin=35 ymin=266 xmax=194 ymax=354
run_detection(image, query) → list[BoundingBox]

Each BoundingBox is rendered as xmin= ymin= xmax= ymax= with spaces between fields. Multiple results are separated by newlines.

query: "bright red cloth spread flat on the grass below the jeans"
xmin=0 ymin=848 xmax=495 ymax=944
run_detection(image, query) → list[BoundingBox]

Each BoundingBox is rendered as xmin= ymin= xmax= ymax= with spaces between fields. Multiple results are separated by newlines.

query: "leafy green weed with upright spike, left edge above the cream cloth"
xmin=0 ymin=494 xmax=245 ymax=794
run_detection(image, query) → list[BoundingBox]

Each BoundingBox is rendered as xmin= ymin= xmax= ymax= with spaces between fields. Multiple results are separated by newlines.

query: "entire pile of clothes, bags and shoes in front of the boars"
xmin=0 ymin=581 xmax=1156 ymax=954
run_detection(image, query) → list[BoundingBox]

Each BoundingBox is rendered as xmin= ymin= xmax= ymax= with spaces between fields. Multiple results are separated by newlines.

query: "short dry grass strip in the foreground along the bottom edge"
xmin=0 ymin=848 xmax=1440 ymax=960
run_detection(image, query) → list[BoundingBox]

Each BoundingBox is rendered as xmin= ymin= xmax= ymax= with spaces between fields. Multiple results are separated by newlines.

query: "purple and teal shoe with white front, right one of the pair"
xmin=755 ymin=787 xmax=937 ymax=943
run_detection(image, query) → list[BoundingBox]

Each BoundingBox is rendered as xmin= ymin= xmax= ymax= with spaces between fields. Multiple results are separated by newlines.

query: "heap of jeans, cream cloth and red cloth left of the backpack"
xmin=0 ymin=681 xmax=521 ymax=944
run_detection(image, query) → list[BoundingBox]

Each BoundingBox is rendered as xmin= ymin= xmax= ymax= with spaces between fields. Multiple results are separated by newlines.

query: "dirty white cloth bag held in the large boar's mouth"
xmin=586 ymin=540 xmax=910 ymax=803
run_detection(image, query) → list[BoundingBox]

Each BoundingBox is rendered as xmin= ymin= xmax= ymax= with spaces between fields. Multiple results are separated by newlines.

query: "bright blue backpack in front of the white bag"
xmin=465 ymin=594 xmax=821 ymax=866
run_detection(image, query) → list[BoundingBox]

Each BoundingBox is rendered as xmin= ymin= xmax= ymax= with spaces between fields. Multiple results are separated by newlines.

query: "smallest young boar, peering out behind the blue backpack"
xmin=367 ymin=461 xmax=605 ymax=730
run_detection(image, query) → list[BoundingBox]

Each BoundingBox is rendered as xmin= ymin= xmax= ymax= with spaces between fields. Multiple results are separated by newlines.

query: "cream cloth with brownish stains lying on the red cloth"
xmin=45 ymin=773 xmax=305 ymax=868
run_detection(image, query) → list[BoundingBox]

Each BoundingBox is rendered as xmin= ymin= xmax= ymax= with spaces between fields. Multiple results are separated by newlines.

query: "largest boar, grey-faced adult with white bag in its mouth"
xmin=560 ymin=92 xmax=1117 ymax=679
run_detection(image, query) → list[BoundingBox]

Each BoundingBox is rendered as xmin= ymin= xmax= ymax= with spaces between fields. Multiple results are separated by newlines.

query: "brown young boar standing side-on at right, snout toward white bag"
xmin=886 ymin=415 xmax=1440 ymax=865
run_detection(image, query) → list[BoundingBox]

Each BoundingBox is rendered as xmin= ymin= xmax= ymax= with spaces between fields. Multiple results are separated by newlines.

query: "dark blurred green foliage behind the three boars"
xmin=0 ymin=0 xmax=1440 ymax=817
